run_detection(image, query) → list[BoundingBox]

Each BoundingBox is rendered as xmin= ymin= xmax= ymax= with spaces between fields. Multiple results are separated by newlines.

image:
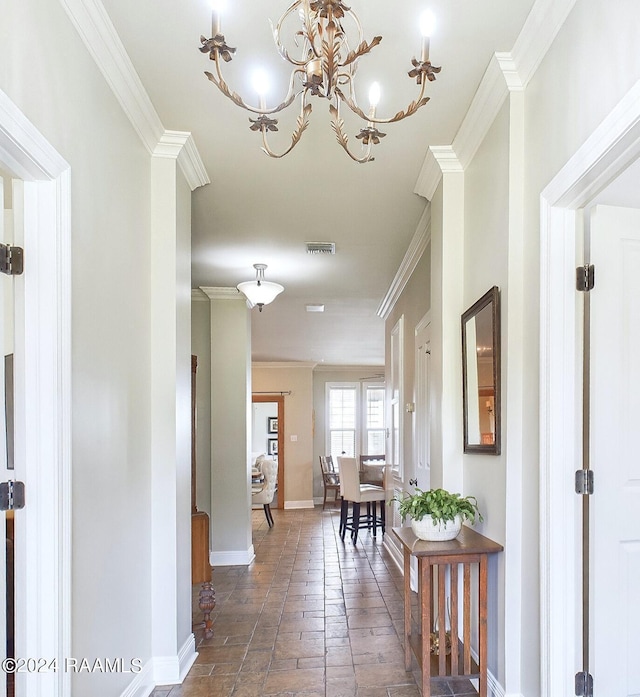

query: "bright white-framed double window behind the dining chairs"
xmin=326 ymin=382 xmax=385 ymax=458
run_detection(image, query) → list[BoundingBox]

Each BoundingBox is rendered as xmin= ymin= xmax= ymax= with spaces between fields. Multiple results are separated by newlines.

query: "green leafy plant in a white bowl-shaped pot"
xmin=389 ymin=487 xmax=483 ymax=541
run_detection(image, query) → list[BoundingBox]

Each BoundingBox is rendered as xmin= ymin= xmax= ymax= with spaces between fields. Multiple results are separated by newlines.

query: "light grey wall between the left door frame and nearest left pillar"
xmin=0 ymin=0 xmax=152 ymax=697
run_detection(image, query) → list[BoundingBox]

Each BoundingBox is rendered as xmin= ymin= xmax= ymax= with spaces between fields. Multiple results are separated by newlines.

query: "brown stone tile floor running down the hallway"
xmin=151 ymin=506 xmax=477 ymax=697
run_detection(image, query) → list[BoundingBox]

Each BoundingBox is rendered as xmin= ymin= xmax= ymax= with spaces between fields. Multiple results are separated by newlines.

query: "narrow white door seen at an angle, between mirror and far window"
xmin=413 ymin=320 xmax=431 ymax=491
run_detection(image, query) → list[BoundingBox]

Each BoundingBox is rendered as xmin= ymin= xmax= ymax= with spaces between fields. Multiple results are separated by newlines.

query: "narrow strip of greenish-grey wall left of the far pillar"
xmin=191 ymin=298 xmax=211 ymax=518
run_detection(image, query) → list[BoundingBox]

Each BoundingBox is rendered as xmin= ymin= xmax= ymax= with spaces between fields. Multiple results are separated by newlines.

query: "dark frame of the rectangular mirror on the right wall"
xmin=462 ymin=286 xmax=501 ymax=455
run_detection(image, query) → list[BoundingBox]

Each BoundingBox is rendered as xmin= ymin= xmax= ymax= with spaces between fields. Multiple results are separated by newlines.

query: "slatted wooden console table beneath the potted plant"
xmin=393 ymin=525 xmax=503 ymax=697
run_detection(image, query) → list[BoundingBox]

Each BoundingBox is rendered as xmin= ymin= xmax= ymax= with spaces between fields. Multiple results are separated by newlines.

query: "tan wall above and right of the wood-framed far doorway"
xmin=251 ymin=363 xmax=313 ymax=508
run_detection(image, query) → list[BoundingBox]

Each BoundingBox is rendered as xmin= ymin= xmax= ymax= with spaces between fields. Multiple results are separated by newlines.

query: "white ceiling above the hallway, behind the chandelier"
xmin=103 ymin=0 xmax=533 ymax=365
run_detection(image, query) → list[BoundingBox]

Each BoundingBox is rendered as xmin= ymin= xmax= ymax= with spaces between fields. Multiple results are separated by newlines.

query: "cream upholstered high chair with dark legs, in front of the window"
xmin=338 ymin=457 xmax=385 ymax=544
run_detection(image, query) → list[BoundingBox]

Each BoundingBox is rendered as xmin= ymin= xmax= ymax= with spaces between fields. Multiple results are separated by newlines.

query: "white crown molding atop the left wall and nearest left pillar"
xmin=60 ymin=0 xmax=210 ymax=191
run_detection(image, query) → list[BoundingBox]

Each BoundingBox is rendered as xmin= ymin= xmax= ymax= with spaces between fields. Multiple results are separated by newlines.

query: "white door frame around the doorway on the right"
xmin=540 ymin=81 xmax=640 ymax=695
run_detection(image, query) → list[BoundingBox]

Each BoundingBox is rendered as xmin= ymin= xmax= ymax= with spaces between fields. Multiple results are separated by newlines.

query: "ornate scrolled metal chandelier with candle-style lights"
xmin=200 ymin=0 xmax=440 ymax=163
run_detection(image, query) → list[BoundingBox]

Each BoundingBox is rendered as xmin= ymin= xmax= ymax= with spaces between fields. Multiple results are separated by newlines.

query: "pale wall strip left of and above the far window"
xmin=312 ymin=366 xmax=384 ymax=502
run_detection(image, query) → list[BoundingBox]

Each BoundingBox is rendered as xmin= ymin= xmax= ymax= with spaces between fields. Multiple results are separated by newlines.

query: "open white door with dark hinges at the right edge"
xmin=590 ymin=206 xmax=640 ymax=697
